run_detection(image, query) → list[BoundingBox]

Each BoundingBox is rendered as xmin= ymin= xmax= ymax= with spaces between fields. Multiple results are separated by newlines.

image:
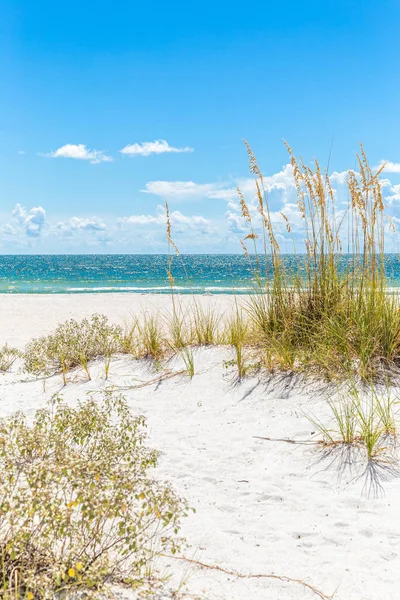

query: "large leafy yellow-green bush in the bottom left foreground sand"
xmin=0 ymin=393 xmax=187 ymax=600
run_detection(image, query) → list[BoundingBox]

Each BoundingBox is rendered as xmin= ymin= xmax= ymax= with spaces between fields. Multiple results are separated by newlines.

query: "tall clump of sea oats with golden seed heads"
xmin=238 ymin=145 xmax=400 ymax=378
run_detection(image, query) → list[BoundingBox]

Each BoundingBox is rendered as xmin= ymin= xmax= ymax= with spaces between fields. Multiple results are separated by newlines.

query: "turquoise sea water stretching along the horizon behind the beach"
xmin=0 ymin=254 xmax=400 ymax=294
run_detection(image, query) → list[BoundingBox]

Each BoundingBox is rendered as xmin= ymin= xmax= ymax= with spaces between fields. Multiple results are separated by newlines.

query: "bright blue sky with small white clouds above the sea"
xmin=0 ymin=0 xmax=400 ymax=253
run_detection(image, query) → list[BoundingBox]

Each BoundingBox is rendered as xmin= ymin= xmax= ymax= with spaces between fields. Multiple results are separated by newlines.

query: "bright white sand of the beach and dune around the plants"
xmin=0 ymin=294 xmax=400 ymax=600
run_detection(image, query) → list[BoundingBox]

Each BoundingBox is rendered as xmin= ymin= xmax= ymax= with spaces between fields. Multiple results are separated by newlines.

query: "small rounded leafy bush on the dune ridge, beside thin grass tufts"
xmin=24 ymin=314 xmax=123 ymax=383
